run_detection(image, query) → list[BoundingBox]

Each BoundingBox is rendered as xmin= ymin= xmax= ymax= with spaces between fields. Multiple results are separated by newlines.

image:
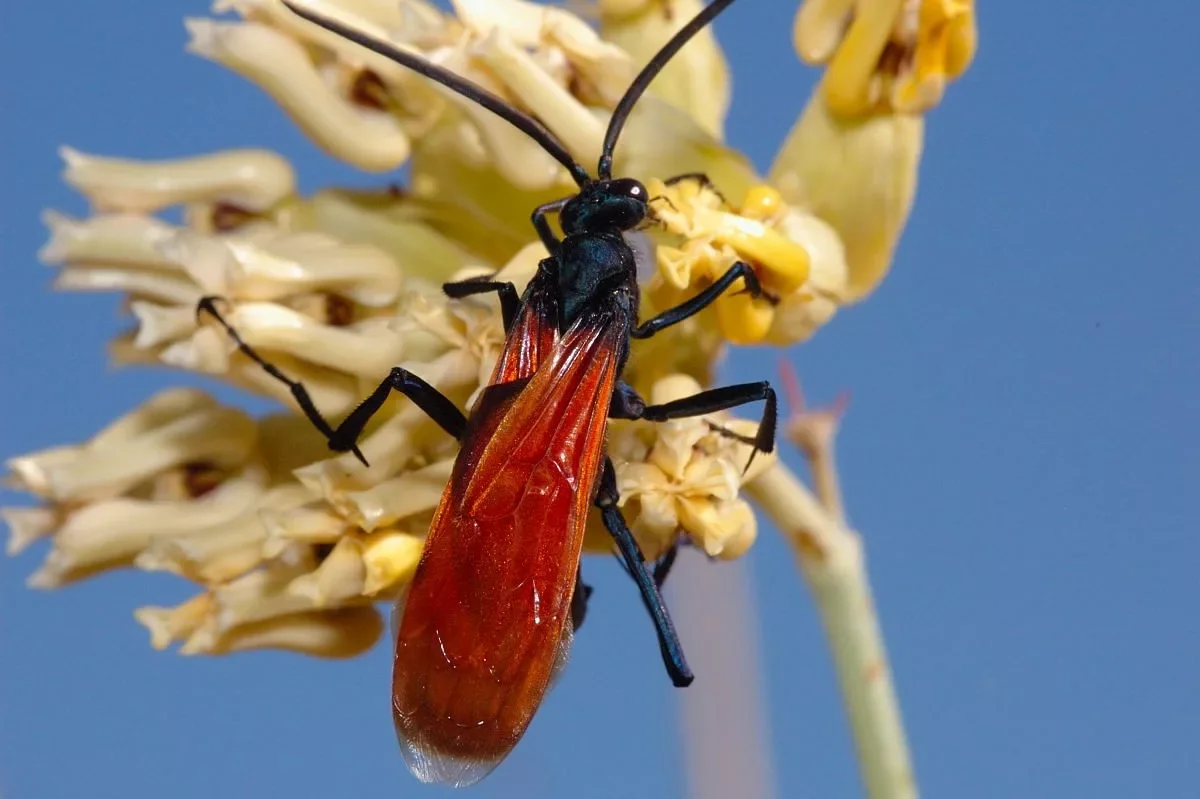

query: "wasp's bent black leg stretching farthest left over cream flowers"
xmin=196 ymin=296 xmax=467 ymax=465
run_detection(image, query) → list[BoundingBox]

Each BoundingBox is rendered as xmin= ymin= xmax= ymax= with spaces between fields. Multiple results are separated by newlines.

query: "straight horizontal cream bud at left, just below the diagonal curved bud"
xmin=59 ymin=148 xmax=295 ymax=214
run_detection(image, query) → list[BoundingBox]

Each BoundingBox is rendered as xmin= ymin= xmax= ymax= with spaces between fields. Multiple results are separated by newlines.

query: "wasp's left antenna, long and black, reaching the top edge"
xmin=283 ymin=0 xmax=592 ymax=186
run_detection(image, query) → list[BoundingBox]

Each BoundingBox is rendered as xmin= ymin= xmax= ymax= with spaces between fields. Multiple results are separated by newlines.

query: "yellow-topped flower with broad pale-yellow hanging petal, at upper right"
xmin=769 ymin=0 xmax=976 ymax=302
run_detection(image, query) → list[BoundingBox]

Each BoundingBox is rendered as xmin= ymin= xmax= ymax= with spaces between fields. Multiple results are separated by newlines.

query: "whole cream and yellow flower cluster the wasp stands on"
xmin=0 ymin=0 xmax=974 ymax=656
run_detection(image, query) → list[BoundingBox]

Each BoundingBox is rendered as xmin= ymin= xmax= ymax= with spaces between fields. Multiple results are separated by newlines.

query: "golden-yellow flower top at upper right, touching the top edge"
xmin=794 ymin=0 xmax=977 ymax=118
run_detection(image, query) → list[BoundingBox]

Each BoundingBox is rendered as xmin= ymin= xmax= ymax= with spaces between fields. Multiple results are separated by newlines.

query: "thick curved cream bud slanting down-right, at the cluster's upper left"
xmin=186 ymin=19 xmax=410 ymax=172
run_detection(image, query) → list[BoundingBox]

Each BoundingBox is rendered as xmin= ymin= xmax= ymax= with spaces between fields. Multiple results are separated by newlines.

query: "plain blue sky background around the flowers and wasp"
xmin=0 ymin=0 xmax=1200 ymax=799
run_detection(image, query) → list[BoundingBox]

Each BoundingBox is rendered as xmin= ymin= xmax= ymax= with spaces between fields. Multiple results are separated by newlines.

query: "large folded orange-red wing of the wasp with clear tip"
xmin=392 ymin=314 xmax=622 ymax=786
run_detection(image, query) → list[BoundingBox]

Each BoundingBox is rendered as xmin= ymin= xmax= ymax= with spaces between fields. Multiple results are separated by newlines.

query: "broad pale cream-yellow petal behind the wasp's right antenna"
xmin=598 ymin=0 xmax=730 ymax=139
